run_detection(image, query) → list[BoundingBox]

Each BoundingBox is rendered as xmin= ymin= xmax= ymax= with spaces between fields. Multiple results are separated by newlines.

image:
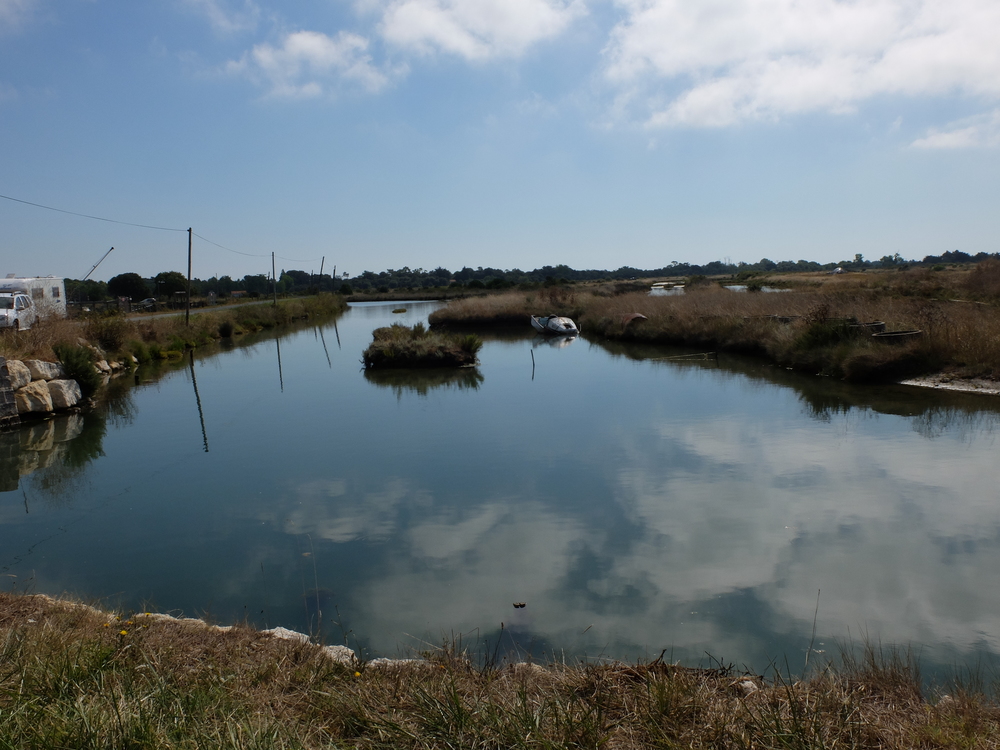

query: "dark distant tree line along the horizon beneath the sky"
xmin=66 ymin=250 xmax=1000 ymax=302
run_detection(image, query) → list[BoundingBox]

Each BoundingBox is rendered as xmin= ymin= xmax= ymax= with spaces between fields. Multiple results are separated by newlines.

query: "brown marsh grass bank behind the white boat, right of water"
xmin=431 ymin=262 xmax=1000 ymax=382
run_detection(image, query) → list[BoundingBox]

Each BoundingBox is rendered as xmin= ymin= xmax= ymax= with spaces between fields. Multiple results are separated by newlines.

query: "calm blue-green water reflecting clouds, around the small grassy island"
xmin=0 ymin=303 xmax=1000 ymax=670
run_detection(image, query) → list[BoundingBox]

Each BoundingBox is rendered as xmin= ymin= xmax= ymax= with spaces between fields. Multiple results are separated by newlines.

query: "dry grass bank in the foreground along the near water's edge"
xmin=0 ymin=594 xmax=1000 ymax=750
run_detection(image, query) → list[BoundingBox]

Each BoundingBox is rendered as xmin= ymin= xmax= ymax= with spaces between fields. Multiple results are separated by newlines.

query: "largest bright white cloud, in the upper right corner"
xmin=604 ymin=0 xmax=1000 ymax=127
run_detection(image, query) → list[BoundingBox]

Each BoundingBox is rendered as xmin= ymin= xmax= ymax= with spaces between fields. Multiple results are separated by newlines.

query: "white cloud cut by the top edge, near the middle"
xmin=381 ymin=0 xmax=585 ymax=61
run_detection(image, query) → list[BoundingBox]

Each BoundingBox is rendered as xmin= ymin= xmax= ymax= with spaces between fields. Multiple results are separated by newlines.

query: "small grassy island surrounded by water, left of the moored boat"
xmin=363 ymin=323 xmax=483 ymax=369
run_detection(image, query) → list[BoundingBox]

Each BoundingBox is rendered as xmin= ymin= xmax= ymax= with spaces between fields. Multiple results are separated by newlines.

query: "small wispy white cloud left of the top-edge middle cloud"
xmin=227 ymin=31 xmax=389 ymax=98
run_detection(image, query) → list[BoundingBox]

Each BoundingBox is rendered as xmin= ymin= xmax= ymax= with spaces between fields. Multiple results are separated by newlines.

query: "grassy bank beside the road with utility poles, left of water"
xmin=0 ymin=294 xmax=347 ymax=386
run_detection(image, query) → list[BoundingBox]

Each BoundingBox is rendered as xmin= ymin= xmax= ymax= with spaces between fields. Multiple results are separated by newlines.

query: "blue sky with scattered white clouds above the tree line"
xmin=0 ymin=0 xmax=1000 ymax=279
